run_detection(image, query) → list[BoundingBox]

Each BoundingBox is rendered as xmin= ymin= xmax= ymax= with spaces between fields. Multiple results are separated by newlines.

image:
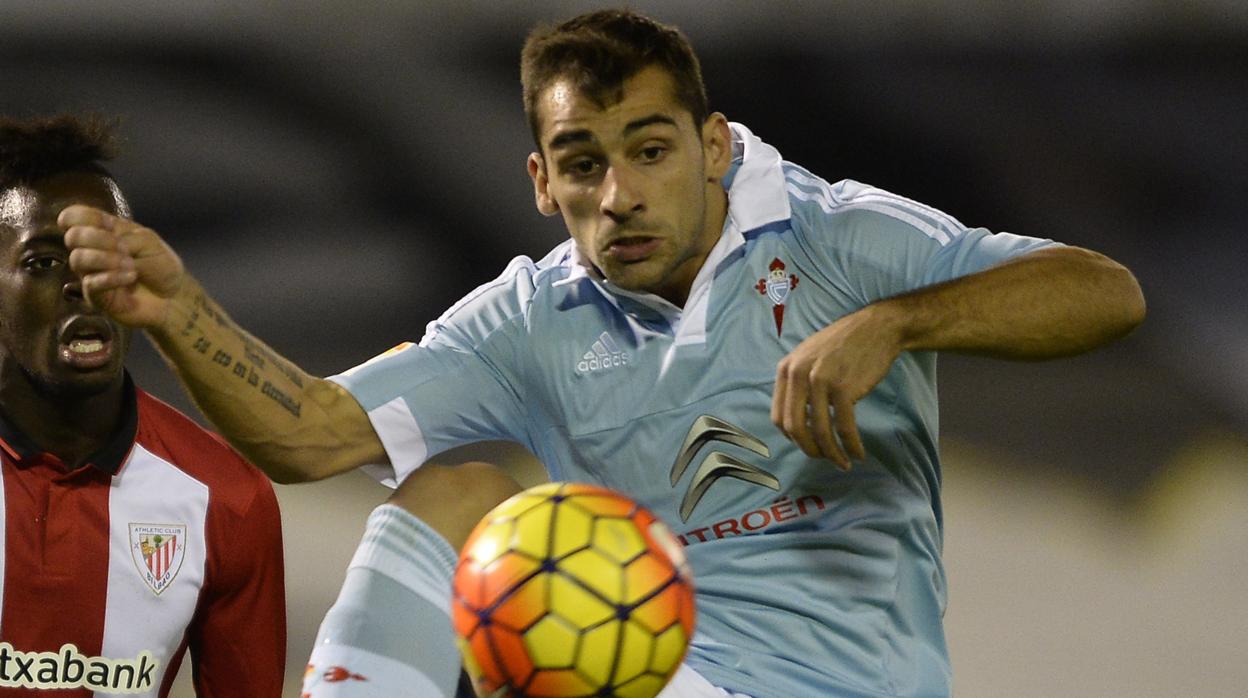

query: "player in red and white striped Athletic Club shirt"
xmin=0 ymin=116 xmax=286 ymax=697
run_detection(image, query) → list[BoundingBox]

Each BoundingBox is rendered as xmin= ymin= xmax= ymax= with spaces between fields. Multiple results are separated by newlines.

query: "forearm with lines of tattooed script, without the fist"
xmin=149 ymin=276 xmax=386 ymax=482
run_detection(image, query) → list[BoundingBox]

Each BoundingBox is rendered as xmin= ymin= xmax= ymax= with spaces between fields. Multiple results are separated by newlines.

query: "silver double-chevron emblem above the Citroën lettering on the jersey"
xmin=671 ymin=415 xmax=780 ymax=521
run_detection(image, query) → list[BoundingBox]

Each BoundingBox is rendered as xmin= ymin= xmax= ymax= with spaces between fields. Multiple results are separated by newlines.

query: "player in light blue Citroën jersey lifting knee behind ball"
xmin=61 ymin=10 xmax=1144 ymax=698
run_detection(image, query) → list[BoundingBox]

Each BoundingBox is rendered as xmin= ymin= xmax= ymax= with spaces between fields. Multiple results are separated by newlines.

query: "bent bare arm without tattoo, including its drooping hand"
xmin=771 ymin=247 xmax=1144 ymax=469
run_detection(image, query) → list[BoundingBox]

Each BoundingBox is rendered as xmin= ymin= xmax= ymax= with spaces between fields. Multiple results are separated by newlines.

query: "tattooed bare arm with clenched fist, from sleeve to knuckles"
xmin=59 ymin=206 xmax=386 ymax=482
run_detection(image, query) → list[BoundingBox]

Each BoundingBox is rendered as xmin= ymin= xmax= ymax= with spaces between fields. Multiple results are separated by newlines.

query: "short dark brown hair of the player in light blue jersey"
xmin=520 ymin=10 xmax=710 ymax=150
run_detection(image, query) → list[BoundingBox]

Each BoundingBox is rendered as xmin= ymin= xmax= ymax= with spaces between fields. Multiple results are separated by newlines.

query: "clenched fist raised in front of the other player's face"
xmin=56 ymin=205 xmax=186 ymax=328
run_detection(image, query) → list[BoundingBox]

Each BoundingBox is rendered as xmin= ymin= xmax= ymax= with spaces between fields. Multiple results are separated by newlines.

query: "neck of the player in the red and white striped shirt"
xmin=0 ymin=371 xmax=125 ymax=467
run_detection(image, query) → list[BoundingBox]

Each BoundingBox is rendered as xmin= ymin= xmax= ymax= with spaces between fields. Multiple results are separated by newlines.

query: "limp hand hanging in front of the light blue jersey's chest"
xmin=771 ymin=303 xmax=901 ymax=471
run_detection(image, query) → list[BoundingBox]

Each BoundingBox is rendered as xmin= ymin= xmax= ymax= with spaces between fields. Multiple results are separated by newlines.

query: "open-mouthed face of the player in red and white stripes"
xmin=0 ymin=172 xmax=130 ymax=397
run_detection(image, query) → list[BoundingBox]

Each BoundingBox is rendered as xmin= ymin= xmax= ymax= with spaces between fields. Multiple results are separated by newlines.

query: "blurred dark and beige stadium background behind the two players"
xmin=0 ymin=0 xmax=1248 ymax=697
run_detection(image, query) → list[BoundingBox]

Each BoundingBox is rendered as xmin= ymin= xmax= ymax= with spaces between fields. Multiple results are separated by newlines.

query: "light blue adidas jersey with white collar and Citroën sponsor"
xmin=334 ymin=124 xmax=1053 ymax=698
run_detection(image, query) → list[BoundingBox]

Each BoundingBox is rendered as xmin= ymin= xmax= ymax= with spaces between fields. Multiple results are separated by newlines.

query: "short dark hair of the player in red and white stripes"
xmin=0 ymin=114 xmax=117 ymax=190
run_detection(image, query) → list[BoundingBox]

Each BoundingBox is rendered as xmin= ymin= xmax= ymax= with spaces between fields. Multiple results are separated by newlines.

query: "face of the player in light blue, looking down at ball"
xmin=529 ymin=67 xmax=731 ymax=305
